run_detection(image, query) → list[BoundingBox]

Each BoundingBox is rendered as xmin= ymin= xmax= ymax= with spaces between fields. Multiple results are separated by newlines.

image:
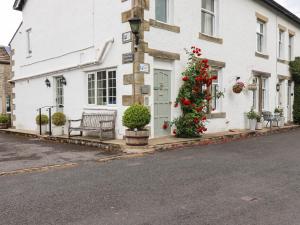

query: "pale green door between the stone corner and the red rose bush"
xmin=154 ymin=70 xmax=171 ymax=137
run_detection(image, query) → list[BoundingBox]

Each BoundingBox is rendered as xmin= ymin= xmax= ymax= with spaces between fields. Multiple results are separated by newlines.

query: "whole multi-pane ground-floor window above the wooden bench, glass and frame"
xmin=88 ymin=70 xmax=117 ymax=105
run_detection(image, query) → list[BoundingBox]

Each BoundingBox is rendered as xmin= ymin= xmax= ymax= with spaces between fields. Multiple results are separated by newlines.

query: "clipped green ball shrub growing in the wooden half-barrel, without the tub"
xmin=123 ymin=104 xmax=151 ymax=130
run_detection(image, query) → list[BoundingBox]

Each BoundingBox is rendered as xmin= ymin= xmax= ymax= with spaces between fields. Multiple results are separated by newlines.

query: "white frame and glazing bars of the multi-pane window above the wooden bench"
xmin=87 ymin=69 xmax=117 ymax=107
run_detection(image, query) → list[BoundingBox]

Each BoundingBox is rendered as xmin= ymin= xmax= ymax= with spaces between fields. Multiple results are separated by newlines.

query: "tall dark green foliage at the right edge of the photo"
xmin=290 ymin=57 xmax=300 ymax=124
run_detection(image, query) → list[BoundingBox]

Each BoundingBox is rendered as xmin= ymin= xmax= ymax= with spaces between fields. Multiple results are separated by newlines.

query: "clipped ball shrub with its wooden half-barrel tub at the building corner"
xmin=123 ymin=104 xmax=151 ymax=146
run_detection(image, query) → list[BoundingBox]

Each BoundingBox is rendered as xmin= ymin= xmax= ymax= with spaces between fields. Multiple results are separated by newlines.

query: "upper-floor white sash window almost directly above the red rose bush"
xmin=201 ymin=0 xmax=216 ymax=36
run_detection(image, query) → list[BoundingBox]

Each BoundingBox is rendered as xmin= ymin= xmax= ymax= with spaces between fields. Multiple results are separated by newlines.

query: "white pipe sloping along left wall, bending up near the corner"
xmin=8 ymin=38 xmax=115 ymax=83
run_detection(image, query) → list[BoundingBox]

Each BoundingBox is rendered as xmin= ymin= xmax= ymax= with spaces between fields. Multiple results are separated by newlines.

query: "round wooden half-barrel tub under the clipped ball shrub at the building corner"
xmin=125 ymin=130 xmax=150 ymax=146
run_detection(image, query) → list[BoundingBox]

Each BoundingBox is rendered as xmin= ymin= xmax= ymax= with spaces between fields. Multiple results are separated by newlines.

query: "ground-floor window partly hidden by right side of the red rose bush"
xmin=211 ymin=68 xmax=222 ymax=112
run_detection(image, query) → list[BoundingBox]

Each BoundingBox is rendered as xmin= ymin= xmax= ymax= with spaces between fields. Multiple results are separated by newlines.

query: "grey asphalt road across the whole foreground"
xmin=0 ymin=130 xmax=300 ymax=225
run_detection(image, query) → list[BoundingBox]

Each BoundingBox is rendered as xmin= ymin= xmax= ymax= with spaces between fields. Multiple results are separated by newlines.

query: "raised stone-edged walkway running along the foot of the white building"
xmin=0 ymin=125 xmax=300 ymax=154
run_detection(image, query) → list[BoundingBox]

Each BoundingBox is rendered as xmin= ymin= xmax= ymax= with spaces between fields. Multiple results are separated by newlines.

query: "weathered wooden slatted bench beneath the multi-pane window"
xmin=68 ymin=110 xmax=117 ymax=140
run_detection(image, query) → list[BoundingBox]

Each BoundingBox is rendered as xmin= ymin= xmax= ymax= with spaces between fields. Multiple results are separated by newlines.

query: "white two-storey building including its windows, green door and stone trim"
xmin=11 ymin=0 xmax=300 ymax=138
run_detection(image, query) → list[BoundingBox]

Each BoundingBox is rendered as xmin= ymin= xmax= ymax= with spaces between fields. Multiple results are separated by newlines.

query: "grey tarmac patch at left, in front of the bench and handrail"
xmin=0 ymin=133 xmax=113 ymax=171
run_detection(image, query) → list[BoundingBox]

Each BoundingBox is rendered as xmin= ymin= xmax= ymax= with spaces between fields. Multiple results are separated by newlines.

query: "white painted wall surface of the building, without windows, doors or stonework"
xmin=11 ymin=0 xmax=300 ymax=138
